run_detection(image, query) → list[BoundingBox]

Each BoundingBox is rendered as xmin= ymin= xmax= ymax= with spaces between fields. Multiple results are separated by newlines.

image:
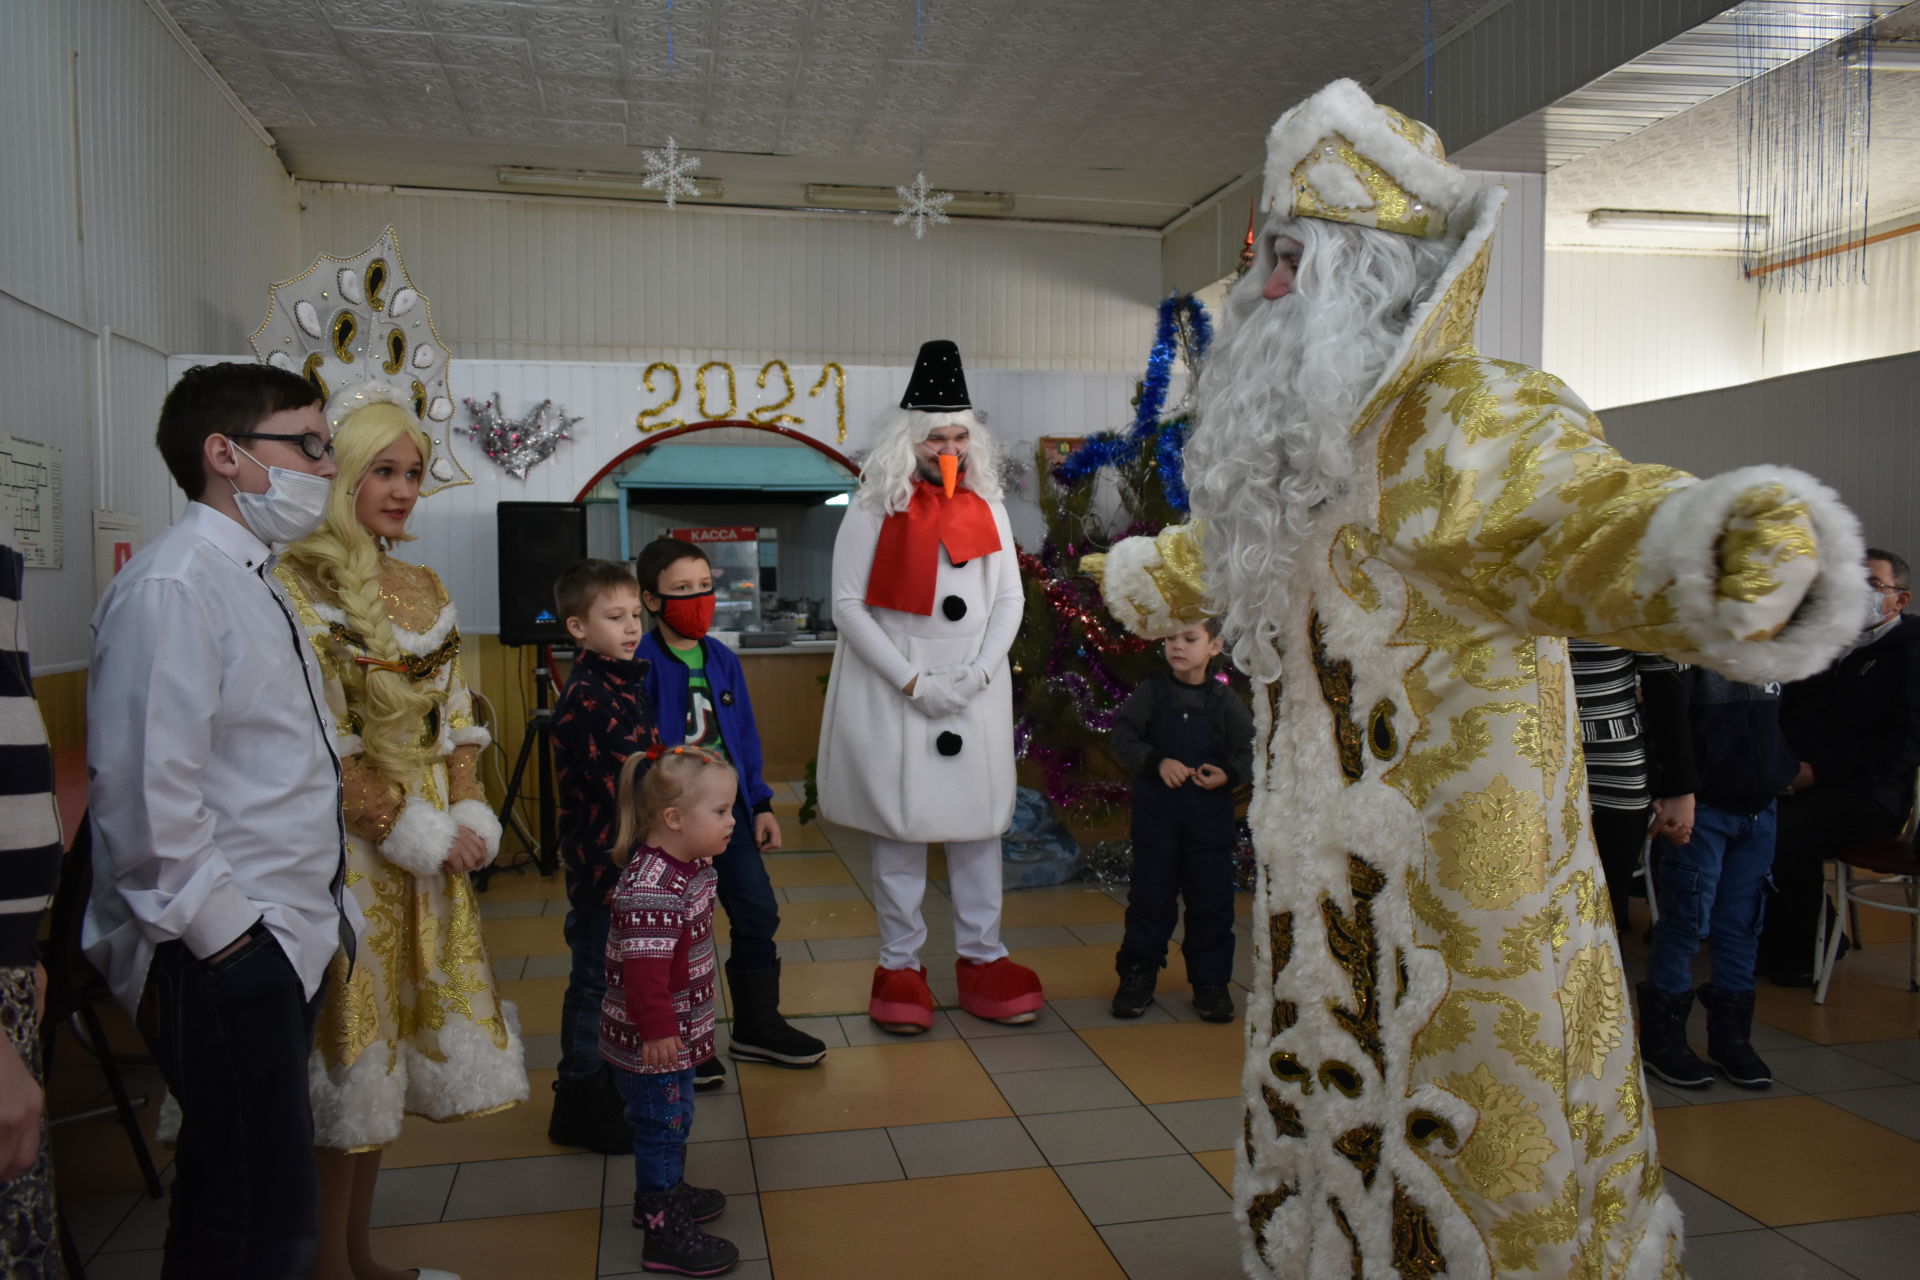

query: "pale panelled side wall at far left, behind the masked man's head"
xmin=0 ymin=0 xmax=300 ymax=672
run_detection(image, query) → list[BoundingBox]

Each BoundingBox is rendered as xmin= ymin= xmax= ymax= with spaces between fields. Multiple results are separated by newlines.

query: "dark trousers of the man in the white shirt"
xmin=142 ymin=933 xmax=321 ymax=1280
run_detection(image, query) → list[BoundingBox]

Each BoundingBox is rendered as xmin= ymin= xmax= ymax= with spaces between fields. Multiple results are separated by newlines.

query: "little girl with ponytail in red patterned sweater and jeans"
xmin=599 ymin=747 xmax=739 ymax=1276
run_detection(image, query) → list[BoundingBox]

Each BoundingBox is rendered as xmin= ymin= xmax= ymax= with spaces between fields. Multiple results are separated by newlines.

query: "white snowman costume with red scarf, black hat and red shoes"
xmin=818 ymin=342 xmax=1043 ymax=1034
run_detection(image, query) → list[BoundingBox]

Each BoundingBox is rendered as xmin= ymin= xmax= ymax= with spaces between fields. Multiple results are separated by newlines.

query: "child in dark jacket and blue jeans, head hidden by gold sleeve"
xmin=1640 ymin=666 xmax=1799 ymax=1088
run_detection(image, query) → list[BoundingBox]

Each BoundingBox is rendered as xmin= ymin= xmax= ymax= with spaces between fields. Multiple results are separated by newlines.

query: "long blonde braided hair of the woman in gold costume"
xmin=284 ymin=403 xmax=444 ymax=791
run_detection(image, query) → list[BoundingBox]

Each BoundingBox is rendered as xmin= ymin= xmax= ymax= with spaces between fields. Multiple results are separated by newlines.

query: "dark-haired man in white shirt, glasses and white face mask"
xmin=84 ymin=365 xmax=359 ymax=1276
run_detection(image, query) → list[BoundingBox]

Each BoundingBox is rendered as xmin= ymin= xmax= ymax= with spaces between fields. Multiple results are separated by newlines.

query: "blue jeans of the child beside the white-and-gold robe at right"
xmin=1647 ymin=804 xmax=1774 ymax=996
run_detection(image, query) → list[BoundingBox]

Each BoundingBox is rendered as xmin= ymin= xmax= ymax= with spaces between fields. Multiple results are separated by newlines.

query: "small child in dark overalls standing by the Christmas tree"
xmin=1112 ymin=618 xmax=1254 ymax=1023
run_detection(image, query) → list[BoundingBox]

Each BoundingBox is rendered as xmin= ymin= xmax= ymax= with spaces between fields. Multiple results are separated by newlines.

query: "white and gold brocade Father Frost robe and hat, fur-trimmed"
xmin=1089 ymin=81 xmax=1860 ymax=1280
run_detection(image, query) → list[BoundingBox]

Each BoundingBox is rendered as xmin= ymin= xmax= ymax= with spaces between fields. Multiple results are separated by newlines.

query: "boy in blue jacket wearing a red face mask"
xmin=637 ymin=537 xmax=828 ymax=1075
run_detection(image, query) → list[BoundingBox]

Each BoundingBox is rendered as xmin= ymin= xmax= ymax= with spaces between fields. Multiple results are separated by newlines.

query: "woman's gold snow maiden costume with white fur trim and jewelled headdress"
xmin=253 ymin=228 xmax=528 ymax=1151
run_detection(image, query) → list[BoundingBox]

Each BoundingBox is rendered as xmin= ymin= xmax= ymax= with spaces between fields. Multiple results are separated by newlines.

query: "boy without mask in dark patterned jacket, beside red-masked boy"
xmin=547 ymin=560 xmax=659 ymax=1155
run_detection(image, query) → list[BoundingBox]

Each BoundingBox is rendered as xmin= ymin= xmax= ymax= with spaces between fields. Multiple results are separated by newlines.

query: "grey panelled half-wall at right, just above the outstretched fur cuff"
xmin=1605 ymin=353 xmax=1920 ymax=558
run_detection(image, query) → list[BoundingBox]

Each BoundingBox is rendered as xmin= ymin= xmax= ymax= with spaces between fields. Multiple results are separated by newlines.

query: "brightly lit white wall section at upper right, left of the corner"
xmin=1542 ymin=249 xmax=1763 ymax=409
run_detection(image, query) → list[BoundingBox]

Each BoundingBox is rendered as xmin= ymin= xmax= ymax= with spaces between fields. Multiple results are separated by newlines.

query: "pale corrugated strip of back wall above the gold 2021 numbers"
xmin=300 ymin=184 xmax=1160 ymax=370
